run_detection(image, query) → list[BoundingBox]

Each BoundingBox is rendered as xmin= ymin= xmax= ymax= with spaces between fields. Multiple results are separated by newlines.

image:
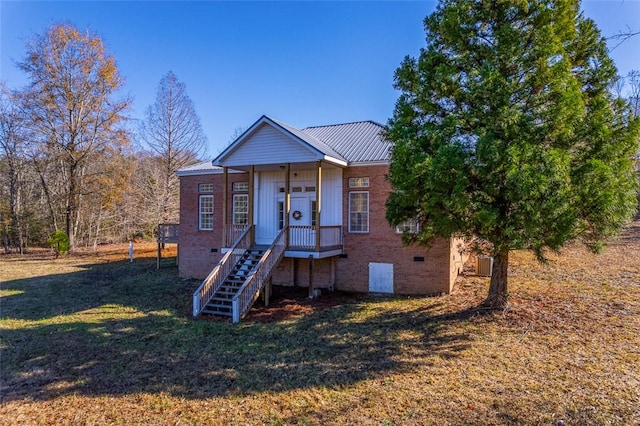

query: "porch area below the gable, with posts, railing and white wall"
xmin=222 ymin=161 xmax=343 ymax=259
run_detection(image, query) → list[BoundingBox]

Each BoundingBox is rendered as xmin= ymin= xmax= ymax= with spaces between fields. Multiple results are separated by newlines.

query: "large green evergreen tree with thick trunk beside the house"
xmin=387 ymin=0 xmax=640 ymax=307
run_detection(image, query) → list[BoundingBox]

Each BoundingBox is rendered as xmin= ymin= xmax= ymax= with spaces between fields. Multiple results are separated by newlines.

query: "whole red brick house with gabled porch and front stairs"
xmin=177 ymin=116 xmax=464 ymax=321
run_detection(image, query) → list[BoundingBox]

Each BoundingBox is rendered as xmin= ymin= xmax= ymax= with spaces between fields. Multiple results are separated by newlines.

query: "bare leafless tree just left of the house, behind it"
xmin=139 ymin=71 xmax=207 ymax=224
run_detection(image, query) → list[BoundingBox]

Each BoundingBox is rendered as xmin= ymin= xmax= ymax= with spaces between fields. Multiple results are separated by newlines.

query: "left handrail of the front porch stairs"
xmin=193 ymin=225 xmax=253 ymax=317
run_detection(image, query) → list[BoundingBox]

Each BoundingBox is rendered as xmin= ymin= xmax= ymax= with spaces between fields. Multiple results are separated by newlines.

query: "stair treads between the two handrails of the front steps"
xmin=202 ymin=246 xmax=268 ymax=317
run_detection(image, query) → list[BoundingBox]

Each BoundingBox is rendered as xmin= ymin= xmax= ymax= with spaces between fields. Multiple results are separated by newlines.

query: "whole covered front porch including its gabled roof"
xmin=213 ymin=116 xmax=347 ymax=258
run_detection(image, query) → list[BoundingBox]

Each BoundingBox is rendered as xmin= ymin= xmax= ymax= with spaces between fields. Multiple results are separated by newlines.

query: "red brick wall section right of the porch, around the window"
xmin=336 ymin=166 xmax=455 ymax=294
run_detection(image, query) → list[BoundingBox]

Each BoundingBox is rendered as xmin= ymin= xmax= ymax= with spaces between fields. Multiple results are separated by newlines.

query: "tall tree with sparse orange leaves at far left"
xmin=18 ymin=25 xmax=130 ymax=247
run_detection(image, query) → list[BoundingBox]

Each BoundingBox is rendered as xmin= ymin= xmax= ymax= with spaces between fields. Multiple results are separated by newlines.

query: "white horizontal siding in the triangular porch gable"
xmin=224 ymin=124 xmax=322 ymax=167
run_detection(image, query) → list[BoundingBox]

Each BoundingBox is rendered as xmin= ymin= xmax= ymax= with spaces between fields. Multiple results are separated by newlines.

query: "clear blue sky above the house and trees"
xmin=0 ymin=0 xmax=640 ymax=156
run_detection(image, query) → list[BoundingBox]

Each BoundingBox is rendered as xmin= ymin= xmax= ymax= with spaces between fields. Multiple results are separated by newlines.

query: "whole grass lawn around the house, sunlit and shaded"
xmin=0 ymin=221 xmax=640 ymax=425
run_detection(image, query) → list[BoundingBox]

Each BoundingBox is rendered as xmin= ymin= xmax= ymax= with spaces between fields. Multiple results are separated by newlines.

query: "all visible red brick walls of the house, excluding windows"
xmin=179 ymin=166 xmax=463 ymax=294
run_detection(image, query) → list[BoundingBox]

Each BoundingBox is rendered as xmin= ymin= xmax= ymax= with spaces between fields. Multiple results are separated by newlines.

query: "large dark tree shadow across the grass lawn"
xmin=0 ymin=255 xmax=472 ymax=402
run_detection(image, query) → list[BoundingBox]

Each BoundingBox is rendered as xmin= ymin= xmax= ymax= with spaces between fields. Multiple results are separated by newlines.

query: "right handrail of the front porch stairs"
xmin=231 ymin=227 xmax=288 ymax=323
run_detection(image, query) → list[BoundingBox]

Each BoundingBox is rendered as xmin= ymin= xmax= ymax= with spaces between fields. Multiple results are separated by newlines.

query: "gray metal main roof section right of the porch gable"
xmin=301 ymin=121 xmax=391 ymax=163
